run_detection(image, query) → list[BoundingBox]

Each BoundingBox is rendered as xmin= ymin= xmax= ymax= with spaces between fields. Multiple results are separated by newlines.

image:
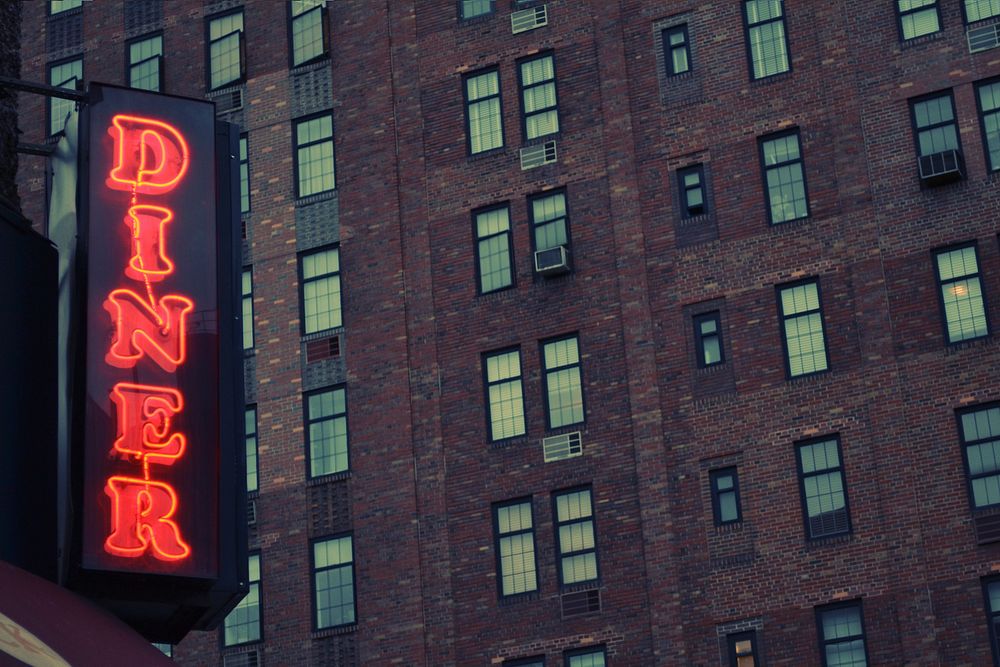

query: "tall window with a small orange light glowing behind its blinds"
xmin=934 ymin=244 xmax=990 ymax=343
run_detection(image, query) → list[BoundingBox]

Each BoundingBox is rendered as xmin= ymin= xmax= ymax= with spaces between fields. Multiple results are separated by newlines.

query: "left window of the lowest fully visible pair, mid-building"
xmin=493 ymin=498 xmax=538 ymax=597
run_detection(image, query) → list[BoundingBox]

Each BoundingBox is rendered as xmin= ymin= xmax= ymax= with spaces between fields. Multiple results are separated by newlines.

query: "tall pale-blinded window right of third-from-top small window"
xmin=778 ymin=280 xmax=830 ymax=377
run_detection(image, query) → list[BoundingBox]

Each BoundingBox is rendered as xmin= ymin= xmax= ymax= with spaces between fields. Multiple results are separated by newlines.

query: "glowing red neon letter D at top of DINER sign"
xmin=107 ymin=114 xmax=190 ymax=195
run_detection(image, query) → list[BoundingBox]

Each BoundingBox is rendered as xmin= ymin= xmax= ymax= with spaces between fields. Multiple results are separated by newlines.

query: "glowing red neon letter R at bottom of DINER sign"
xmin=104 ymin=475 xmax=191 ymax=561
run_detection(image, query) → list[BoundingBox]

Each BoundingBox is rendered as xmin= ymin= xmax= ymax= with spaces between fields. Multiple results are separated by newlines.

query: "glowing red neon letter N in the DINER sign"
xmin=104 ymin=289 xmax=194 ymax=373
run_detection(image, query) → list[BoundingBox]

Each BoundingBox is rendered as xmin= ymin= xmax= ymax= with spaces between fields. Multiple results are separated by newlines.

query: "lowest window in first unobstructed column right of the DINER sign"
xmin=313 ymin=535 xmax=357 ymax=630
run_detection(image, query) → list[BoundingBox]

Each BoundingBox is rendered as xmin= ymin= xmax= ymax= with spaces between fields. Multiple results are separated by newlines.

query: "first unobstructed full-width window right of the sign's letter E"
xmin=306 ymin=387 xmax=349 ymax=477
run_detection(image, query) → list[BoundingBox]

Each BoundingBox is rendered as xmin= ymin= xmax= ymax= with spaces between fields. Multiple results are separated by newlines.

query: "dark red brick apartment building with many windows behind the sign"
xmin=13 ymin=0 xmax=1000 ymax=667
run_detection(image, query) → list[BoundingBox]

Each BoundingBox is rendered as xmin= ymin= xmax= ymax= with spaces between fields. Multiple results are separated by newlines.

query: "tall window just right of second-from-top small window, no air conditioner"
xmin=760 ymin=130 xmax=809 ymax=225
